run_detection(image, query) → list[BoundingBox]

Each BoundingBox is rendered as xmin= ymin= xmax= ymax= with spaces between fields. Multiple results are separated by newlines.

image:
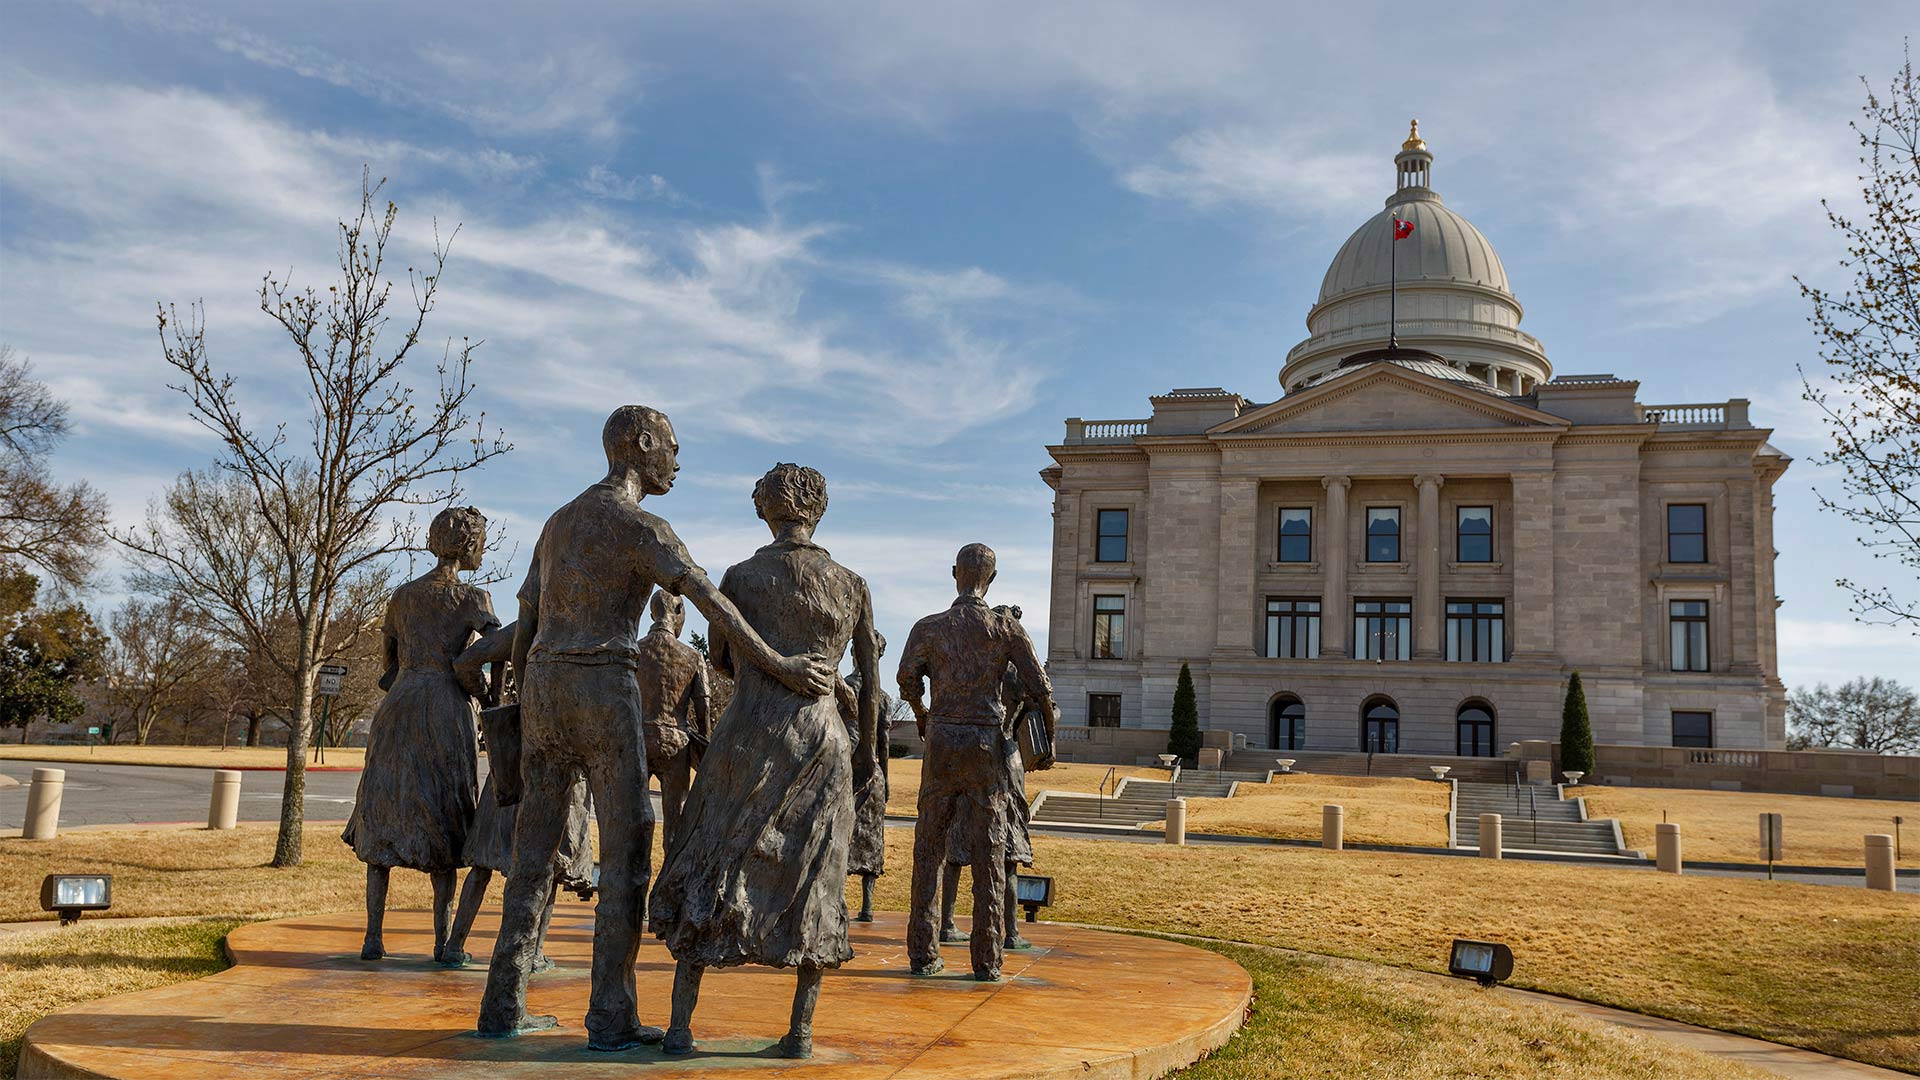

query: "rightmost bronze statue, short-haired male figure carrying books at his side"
xmin=900 ymin=544 xmax=1054 ymax=982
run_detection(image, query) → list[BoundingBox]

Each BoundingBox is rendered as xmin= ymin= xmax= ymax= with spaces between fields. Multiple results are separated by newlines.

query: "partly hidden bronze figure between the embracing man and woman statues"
xmin=634 ymin=588 xmax=712 ymax=849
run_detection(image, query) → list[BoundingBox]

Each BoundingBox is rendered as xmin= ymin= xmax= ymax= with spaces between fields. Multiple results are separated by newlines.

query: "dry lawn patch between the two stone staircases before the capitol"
xmin=1156 ymin=774 xmax=1448 ymax=847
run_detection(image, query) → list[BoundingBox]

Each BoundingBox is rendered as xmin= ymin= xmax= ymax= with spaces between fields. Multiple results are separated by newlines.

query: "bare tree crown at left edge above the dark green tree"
xmin=0 ymin=346 xmax=108 ymax=588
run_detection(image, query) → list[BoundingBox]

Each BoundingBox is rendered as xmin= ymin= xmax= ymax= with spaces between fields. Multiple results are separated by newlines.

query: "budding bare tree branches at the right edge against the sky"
xmin=1799 ymin=48 xmax=1920 ymax=632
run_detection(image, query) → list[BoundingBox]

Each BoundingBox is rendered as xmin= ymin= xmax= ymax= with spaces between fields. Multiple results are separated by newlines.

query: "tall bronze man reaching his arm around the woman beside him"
xmin=480 ymin=405 xmax=835 ymax=1051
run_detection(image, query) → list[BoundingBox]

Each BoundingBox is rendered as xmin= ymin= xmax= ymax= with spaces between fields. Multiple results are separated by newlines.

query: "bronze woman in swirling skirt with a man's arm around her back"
xmin=649 ymin=465 xmax=879 ymax=1057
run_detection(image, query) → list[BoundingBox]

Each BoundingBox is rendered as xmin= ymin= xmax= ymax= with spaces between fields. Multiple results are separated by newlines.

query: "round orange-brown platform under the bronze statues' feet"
xmin=19 ymin=903 xmax=1252 ymax=1080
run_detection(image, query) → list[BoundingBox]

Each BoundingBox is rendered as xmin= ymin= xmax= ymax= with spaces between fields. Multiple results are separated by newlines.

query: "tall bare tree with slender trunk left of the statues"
xmin=117 ymin=181 xmax=511 ymax=867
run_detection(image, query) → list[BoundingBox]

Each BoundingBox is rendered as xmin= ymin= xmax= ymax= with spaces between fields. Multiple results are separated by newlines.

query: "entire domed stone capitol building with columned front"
xmin=1043 ymin=127 xmax=1789 ymax=755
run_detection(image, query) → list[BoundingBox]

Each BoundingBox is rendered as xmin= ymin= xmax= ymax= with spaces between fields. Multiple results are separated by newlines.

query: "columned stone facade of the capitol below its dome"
xmin=1043 ymin=374 xmax=1788 ymax=753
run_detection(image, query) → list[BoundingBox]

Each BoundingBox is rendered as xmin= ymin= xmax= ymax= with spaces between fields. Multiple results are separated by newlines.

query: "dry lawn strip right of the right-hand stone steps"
xmin=1569 ymin=784 xmax=1920 ymax=867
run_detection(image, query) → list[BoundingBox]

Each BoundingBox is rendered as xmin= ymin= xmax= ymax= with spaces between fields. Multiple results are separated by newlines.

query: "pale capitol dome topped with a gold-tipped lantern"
xmin=1281 ymin=129 xmax=1553 ymax=394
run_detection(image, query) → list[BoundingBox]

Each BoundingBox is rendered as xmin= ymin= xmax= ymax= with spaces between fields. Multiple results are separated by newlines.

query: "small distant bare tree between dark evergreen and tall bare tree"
xmin=108 ymin=596 xmax=219 ymax=746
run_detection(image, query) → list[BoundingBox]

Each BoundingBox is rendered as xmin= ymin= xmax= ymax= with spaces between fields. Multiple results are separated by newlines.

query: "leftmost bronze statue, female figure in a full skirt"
xmin=340 ymin=507 xmax=499 ymax=961
